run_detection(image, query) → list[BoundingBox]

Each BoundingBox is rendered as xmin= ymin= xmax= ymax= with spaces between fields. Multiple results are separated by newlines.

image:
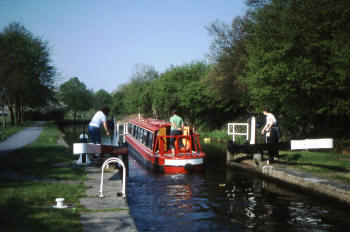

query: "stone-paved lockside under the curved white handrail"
xmin=80 ymin=165 xmax=137 ymax=232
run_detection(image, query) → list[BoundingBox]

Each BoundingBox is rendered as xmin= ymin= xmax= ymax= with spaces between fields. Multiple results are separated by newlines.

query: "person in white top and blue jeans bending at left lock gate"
xmin=88 ymin=107 xmax=110 ymax=144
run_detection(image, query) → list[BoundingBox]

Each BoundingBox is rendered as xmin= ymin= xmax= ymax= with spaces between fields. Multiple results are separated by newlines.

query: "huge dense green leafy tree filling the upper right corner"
xmin=242 ymin=0 xmax=350 ymax=136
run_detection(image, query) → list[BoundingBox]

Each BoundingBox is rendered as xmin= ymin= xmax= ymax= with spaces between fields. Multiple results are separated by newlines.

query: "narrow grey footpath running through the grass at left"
xmin=0 ymin=121 xmax=45 ymax=158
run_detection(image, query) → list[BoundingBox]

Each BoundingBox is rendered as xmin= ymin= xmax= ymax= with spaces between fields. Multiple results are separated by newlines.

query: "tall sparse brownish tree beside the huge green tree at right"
xmin=207 ymin=17 xmax=250 ymax=122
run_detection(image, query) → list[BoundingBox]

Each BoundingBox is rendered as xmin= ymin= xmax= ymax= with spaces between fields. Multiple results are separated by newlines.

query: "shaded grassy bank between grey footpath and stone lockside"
xmin=0 ymin=123 xmax=85 ymax=231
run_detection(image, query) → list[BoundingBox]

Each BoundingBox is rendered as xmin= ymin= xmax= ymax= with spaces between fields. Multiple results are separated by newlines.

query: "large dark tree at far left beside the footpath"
xmin=0 ymin=22 xmax=56 ymax=123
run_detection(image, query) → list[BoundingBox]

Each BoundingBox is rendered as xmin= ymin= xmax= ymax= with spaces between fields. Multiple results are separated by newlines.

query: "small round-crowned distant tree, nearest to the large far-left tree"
xmin=59 ymin=77 xmax=93 ymax=119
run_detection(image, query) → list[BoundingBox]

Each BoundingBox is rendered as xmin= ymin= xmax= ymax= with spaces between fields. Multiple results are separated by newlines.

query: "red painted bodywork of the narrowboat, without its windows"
xmin=126 ymin=118 xmax=206 ymax=173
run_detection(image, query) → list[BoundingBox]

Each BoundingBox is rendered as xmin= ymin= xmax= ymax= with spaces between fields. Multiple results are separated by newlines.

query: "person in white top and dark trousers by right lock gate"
xmin=261 ymin=108 xmax=282 ymax=162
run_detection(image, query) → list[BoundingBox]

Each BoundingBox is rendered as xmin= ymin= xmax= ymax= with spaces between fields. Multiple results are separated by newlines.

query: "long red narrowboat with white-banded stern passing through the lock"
xmin=125 ymin=118 xmax=206 ymax=174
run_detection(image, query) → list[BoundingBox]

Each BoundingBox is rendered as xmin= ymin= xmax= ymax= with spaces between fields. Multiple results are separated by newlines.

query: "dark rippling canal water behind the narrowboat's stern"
xmin=61 ymin=125 xmax=350 ymax=232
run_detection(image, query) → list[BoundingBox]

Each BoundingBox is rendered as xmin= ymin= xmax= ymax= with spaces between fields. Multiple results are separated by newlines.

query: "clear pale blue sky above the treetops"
xmin=0 ymin=0 xmax=246 ymax=93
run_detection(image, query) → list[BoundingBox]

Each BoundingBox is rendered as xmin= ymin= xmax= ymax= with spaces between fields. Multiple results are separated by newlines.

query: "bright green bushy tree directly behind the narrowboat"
xmin=152 ymin=62 xmax=220 ymax=128
